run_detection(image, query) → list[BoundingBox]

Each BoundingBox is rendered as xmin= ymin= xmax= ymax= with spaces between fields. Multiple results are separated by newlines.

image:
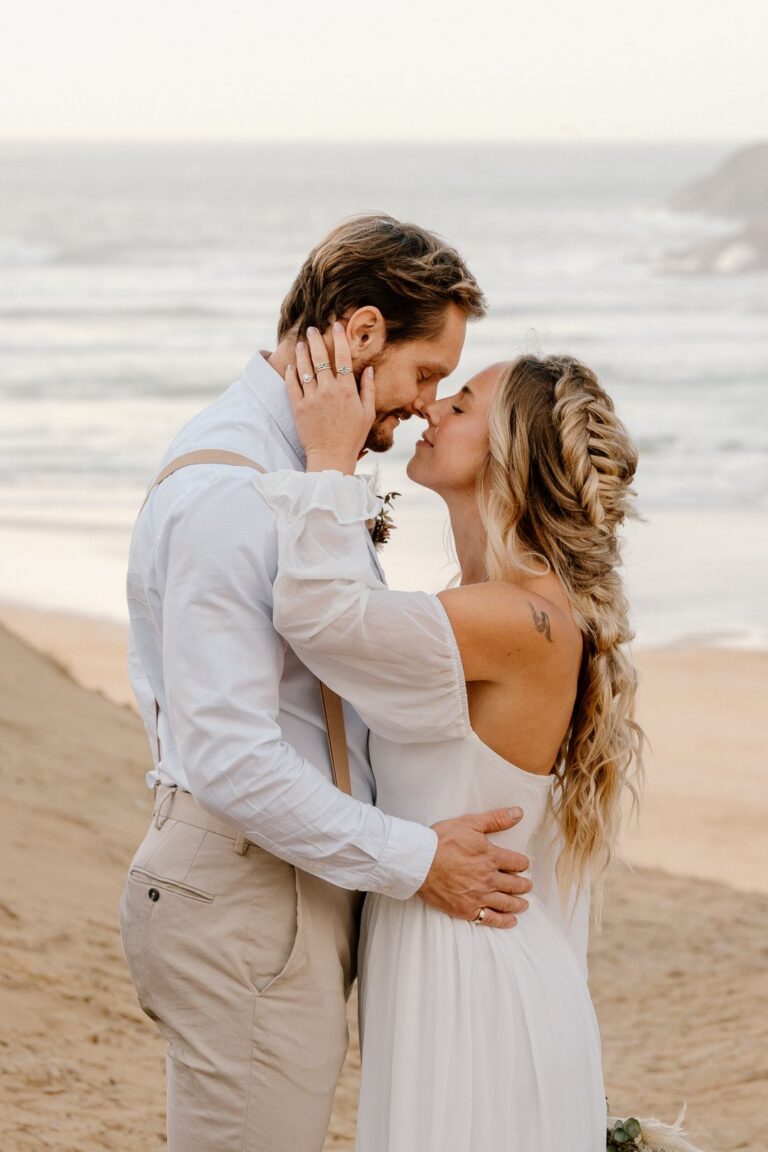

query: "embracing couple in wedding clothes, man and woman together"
xmin=121 ymin=215 xmax=640 ymax=1152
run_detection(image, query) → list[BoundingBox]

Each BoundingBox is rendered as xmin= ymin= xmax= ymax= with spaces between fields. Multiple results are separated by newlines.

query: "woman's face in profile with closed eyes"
xmin=406 ymin=363 xmax=508 ymax=497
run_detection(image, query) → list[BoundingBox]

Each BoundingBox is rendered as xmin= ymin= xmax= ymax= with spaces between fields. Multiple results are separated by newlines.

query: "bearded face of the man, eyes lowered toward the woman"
xmin=365 ymin=304 xmax=466 ymax=452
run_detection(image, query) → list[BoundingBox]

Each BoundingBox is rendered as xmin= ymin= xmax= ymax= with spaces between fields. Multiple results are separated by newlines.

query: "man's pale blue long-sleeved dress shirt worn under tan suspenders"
xmin=128 ymin=354 xmax=436 ymax=899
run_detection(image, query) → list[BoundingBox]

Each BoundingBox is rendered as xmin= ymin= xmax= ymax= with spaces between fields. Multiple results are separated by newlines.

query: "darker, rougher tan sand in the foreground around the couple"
xmin=0 ymin=629 xmax=768 ymax=1152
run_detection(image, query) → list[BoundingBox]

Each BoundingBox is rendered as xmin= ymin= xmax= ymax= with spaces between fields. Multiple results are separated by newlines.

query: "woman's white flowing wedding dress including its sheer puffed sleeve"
xmin=254 ymin=471 xmax=606 ymax=1152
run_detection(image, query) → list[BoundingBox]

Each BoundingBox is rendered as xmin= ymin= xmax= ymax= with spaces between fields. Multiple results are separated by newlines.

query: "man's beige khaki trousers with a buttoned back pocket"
xmin=120 ymin=787 xmax=362 ymax=1152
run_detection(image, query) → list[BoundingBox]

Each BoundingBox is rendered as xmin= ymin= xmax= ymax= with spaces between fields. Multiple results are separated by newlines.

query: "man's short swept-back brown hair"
xmin=277 ymin=214 xmax=486 ymax=343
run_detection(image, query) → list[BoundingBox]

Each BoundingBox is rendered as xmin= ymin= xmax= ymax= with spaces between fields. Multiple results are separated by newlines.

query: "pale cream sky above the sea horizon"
xmin=6 ymin=0 xmax=768 ymax=142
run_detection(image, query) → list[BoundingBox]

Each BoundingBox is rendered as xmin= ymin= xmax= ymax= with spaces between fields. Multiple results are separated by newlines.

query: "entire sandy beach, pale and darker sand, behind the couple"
xmin=0 ymin=606 xmax=768 ymax=1152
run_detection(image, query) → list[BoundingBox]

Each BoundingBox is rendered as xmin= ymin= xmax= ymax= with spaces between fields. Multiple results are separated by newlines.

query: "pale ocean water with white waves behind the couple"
xmin=0 ymin=144 xmax=768 ymax=646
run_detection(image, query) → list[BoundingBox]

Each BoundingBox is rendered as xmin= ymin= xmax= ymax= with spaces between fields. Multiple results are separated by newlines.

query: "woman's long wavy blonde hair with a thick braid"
xmin=479 ymin=356 xmax=644 ymax=923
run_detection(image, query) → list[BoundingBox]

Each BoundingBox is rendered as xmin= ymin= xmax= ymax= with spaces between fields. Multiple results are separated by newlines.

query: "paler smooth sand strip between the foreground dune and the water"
xmin=0 ymin=604 xmax=768 ymax=893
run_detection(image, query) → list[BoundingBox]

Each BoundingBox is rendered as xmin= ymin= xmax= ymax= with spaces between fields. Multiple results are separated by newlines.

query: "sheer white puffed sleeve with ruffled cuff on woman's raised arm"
xmin=253 ymin=471 xmax=470 ymax=742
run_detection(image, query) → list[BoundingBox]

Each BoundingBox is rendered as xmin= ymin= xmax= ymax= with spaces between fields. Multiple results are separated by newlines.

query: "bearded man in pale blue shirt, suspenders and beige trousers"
xmin=121 ymin=217 xmax=531 ymax=1152
